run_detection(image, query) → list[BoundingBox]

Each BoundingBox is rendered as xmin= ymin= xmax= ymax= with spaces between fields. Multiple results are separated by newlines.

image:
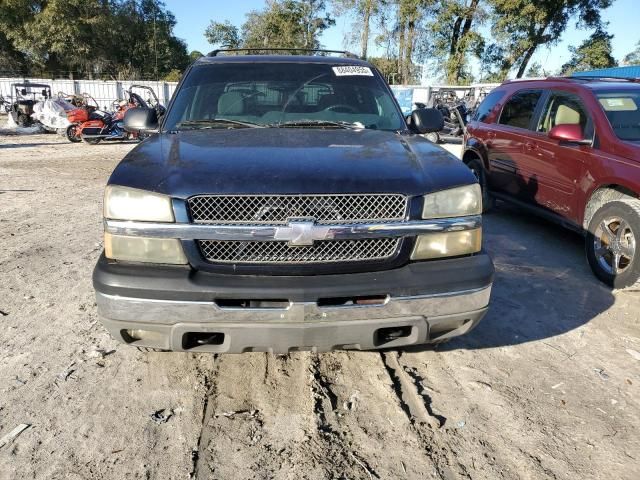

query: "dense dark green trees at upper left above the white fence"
xmin=0 ymin=0 xmax=189 ymax=78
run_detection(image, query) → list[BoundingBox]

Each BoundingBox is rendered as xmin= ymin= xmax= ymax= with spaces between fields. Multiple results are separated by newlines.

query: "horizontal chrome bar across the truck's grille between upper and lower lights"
xmin=104 ymin=215 xmax=482 ymax=243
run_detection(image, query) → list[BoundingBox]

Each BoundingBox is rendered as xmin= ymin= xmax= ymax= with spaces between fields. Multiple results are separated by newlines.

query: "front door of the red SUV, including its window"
xmin=520 ymin=90 xmax=594 ymax=224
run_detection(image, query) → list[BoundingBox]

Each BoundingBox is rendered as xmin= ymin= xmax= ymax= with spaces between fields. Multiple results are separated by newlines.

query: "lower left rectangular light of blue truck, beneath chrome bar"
xmin=104 ymin=233 xmax=188 ymax=265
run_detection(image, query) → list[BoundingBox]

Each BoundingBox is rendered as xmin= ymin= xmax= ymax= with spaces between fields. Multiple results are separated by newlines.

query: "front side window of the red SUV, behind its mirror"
xmin=537 ymin=92 xmax=593 ymax=139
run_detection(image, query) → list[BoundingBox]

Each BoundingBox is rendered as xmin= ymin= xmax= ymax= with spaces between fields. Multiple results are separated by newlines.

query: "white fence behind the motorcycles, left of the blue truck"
xmin=0 ymin=77 xmax=178 ymax=109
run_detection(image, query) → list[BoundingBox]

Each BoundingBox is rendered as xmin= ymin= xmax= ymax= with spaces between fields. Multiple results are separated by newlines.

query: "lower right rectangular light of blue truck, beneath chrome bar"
xmin=411 ymin=228 xmax=482 ymax=260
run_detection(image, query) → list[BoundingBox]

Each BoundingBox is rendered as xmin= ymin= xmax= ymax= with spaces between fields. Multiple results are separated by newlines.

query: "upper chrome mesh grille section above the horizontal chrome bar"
xmin=188 ymin=193 xmax=408 ymax=225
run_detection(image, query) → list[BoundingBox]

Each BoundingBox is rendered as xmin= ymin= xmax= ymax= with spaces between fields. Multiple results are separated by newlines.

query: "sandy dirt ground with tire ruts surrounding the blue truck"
xmin=0 ymin=134 xmax=640 ymax=480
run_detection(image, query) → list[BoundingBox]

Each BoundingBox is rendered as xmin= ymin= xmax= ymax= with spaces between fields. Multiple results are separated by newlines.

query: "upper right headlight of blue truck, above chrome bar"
xmin=422 ymin=183 xmax=482 ymax=218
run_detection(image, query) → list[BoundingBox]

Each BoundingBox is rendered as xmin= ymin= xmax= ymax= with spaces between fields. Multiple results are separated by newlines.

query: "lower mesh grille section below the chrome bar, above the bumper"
xmin=198 ymin=238 xmax=400 ymax=264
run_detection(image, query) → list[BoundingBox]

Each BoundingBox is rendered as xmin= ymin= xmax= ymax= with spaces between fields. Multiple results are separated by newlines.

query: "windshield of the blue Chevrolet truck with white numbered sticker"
xmin=164 ymin=62 xmax=406 ymax=130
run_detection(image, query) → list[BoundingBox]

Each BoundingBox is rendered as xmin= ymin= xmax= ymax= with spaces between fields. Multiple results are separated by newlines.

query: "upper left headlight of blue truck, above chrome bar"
xmin=104 ymin=185 xmax=175 ymax=222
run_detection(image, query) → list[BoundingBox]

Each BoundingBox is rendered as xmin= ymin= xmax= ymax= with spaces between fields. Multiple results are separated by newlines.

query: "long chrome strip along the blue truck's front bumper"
xmin=96 ymin=285 xmax=491 ymax=325
